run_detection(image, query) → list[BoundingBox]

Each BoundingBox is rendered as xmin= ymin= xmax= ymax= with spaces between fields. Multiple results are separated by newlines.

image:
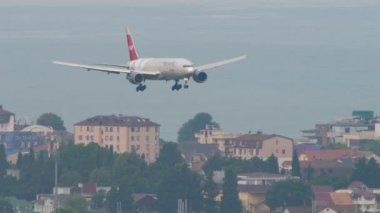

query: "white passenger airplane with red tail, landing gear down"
xmin=53 ymin=29 xmax=246 ymax=92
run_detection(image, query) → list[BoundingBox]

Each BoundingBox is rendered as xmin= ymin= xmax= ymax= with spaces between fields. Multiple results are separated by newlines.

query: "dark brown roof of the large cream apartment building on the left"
xmin=75 ymin=115 xmax=160 ymax=127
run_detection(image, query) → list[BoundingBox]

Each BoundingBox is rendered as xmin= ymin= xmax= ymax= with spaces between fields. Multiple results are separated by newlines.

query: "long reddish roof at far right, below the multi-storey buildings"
xmin=299 ymin=149 xmax=367 ymax=160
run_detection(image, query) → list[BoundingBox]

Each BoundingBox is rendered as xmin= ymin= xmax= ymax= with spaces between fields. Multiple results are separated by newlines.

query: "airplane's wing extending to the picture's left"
xmin=53 ymin=61 xmax=159 ymax=76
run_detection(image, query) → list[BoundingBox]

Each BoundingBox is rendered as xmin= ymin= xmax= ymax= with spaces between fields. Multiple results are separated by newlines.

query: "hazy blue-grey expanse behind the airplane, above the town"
xmin=0 ymin=0 xmax=380 ymax=140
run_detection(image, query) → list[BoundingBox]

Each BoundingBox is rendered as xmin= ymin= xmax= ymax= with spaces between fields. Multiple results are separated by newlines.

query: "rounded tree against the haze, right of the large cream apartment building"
xmin=177 ymin=113 xmax=212 ymax=143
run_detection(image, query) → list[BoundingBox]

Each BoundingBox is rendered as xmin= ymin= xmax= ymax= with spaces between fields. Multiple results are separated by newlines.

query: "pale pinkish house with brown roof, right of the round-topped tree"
xmin=225 ymin=132 xmax=293 ymax=165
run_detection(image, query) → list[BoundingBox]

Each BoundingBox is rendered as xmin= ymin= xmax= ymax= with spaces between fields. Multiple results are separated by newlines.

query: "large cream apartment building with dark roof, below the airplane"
xmin=74 ymin=115 xmax=160 ymax=163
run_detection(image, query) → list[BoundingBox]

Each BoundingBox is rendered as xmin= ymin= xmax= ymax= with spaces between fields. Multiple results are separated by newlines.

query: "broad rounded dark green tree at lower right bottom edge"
xmin=265 ymin=180 xmax=313 ymax=209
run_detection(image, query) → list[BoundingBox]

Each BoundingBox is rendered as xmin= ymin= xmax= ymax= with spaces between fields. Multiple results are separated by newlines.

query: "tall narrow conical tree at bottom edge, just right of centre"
xmin=220 ymin=170 xmax=242 ymax=213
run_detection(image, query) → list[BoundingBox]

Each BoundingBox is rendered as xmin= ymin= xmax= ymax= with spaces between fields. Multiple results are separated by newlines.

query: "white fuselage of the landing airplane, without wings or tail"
xmin=129 ymin=58 xmax=194 ymax=80
